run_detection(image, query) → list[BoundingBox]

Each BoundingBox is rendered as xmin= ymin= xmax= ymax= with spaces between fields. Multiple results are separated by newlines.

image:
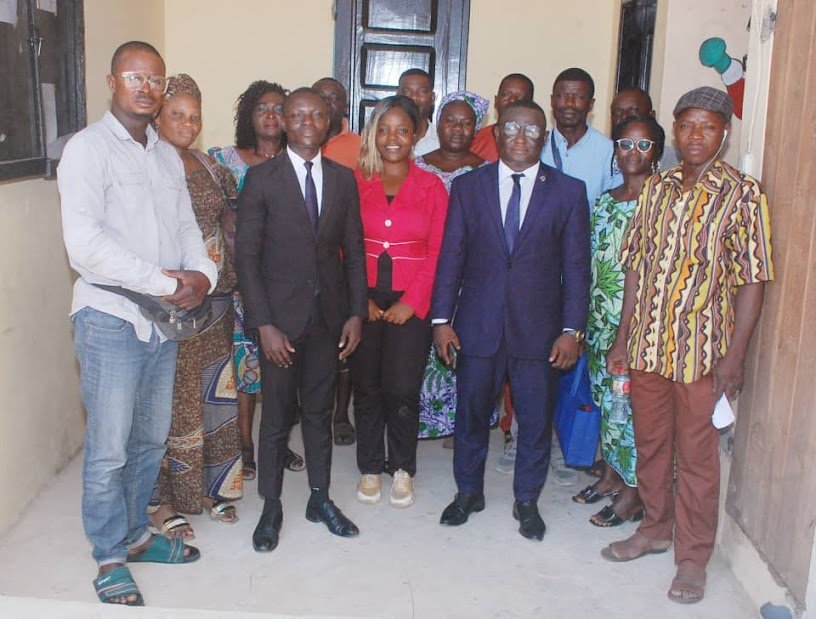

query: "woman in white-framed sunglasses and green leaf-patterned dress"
xmin=573 ymin=116 xmax=665 ymax=527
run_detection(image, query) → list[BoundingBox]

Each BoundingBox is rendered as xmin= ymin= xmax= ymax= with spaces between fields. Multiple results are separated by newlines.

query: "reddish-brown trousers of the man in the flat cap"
xmin=630 ymin=370 xmax=720 ymax=568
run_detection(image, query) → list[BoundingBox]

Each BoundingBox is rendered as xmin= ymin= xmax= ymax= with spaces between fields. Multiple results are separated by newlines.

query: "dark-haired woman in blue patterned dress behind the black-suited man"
xmin=209 ymin=80 xmax=306 ymax=480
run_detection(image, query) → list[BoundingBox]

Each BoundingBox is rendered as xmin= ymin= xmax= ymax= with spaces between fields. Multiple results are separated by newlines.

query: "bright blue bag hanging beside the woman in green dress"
xmin=555 ymin=354 xmax=601 ymax=467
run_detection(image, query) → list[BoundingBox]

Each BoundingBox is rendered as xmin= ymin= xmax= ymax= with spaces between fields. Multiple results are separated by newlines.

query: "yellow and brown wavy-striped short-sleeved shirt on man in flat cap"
xmin=621 ymin=161 xmax=773 ymax=383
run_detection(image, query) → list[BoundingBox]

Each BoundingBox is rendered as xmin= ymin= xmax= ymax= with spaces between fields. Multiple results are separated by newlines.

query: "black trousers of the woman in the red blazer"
xmin=350 ymin=316 xmax=431 ymax=477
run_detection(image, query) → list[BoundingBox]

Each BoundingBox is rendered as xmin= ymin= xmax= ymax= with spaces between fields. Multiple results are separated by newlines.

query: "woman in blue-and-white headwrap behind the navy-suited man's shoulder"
xmin=414 ymin=90 xmax=489 ymax=449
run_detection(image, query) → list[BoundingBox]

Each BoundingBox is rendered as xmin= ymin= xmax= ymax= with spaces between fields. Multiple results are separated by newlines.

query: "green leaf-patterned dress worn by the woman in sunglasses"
xmin=586 ymin=192 xmax=637 ymax=486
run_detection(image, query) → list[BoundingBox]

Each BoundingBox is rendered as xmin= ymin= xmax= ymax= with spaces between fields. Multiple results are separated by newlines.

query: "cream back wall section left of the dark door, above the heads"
xmin=164 ymin=0 xmax=334 ymax=148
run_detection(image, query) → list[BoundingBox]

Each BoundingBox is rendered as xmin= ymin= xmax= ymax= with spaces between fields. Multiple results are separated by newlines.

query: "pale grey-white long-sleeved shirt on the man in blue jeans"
xmin=57 ymin=112 xmax=218 ymax=342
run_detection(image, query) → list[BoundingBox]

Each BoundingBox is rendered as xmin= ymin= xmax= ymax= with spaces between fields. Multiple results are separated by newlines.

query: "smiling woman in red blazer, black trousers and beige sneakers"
xmin=350 ymin=95 xmax=448 ymax=507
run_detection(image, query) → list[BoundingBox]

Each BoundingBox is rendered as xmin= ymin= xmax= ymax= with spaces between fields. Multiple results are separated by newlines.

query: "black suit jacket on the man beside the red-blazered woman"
xmin=235 ymin=151 xmax=368 ymax=340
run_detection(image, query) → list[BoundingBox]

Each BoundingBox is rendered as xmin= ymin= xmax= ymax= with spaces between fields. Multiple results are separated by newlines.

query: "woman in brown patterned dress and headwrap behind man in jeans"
xmin=150 ymin=73 xmax=243 ymax=539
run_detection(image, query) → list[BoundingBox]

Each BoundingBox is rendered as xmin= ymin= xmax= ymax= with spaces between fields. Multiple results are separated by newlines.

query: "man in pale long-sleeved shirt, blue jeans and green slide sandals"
xmin=58 ymin=41 xmax=218 ymax=605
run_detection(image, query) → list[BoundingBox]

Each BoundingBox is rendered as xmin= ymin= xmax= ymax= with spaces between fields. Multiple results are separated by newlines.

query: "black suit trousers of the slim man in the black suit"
xmin=258 ymin=298 xmax=339 ymax=499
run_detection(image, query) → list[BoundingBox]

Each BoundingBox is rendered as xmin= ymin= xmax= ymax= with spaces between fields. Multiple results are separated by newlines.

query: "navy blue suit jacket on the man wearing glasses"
xmin=430 ymin=163 xmax=590 ymax=359
